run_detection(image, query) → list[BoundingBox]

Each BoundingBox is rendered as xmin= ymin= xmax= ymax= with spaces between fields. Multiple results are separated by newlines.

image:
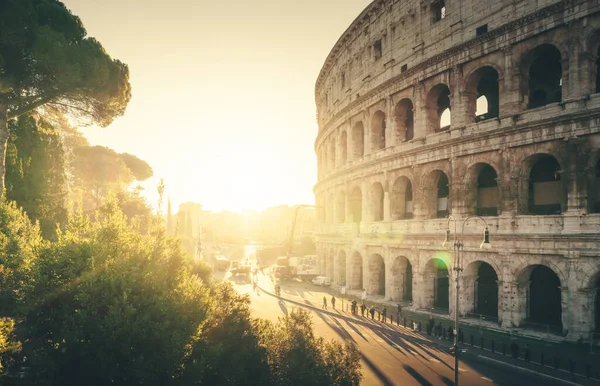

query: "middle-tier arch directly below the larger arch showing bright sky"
xmin=465 ymin=163 xmax=500 ymax=216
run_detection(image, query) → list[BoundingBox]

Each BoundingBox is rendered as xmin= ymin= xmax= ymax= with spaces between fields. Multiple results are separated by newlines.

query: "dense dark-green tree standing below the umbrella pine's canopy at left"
xmin=6 ymin=115 xmax=67 ymax=238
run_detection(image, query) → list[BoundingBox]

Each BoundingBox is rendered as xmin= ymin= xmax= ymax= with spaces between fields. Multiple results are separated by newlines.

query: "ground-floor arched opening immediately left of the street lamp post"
xmin=423 ymin=258 xmax=450 ymax=311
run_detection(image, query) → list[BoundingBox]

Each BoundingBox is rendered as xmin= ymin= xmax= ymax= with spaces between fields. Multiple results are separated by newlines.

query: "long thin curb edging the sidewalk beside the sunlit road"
xmin=251 ymin=279 xmax=597 ymax=386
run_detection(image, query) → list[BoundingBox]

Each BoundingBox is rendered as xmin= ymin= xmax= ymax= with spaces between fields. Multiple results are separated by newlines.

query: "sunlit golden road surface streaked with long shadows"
xmin=225 ymin=275 xmax=576 ymax=385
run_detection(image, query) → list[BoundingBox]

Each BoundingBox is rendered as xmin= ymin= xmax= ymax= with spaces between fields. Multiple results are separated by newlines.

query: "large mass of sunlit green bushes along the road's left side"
xmin=0 ymin=200 xmax=360 ymax=386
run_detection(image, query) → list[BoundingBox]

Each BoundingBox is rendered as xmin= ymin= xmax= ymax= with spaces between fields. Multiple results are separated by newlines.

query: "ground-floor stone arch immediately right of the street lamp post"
xmin=461 ymin=260 xmax=499 ymax=318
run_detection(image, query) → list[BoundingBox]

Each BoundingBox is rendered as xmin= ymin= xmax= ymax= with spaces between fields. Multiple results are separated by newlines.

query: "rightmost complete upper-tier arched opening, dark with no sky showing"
xmin=524 ymin=44 xmax=562 ymax=109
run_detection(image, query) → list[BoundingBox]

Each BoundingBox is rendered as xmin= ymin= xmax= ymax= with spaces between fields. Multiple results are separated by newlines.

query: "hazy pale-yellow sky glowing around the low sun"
xmin=63 ymin=0 xmax=371 ymax=212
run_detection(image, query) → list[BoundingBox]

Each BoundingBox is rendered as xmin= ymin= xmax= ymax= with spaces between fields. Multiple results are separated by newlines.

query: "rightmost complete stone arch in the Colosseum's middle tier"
xmin=519 ymin=153 xmax=567 ymax=215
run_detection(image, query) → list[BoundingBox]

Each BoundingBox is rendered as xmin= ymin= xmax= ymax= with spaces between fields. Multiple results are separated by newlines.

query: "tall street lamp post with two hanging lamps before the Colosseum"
xmin=442 ymin=216 xmax=492 ymax=386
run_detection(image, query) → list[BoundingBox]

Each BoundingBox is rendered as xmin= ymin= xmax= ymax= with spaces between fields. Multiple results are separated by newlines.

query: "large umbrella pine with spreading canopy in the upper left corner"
xmin=0 ymin=0 xmax=131 ymax=195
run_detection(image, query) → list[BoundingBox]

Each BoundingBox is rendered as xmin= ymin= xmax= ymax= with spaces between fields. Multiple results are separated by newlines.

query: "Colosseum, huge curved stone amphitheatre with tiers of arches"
xmin=314 ymin=0 xmax=600 ymax=340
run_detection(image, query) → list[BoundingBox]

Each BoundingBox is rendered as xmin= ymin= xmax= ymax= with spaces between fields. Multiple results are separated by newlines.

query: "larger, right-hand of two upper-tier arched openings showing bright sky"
xmin=465 ymin=66 xmax=500 ymax=122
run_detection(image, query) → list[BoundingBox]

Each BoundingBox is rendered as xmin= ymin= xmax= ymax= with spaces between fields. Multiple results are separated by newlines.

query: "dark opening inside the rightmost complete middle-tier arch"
xmin=528 ymin=155 xmax=565 ymax=215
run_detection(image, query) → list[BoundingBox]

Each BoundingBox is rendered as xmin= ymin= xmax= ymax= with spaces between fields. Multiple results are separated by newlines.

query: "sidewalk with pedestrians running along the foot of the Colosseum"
xmin=257 ymin=271 xmax=600 ymax=385
